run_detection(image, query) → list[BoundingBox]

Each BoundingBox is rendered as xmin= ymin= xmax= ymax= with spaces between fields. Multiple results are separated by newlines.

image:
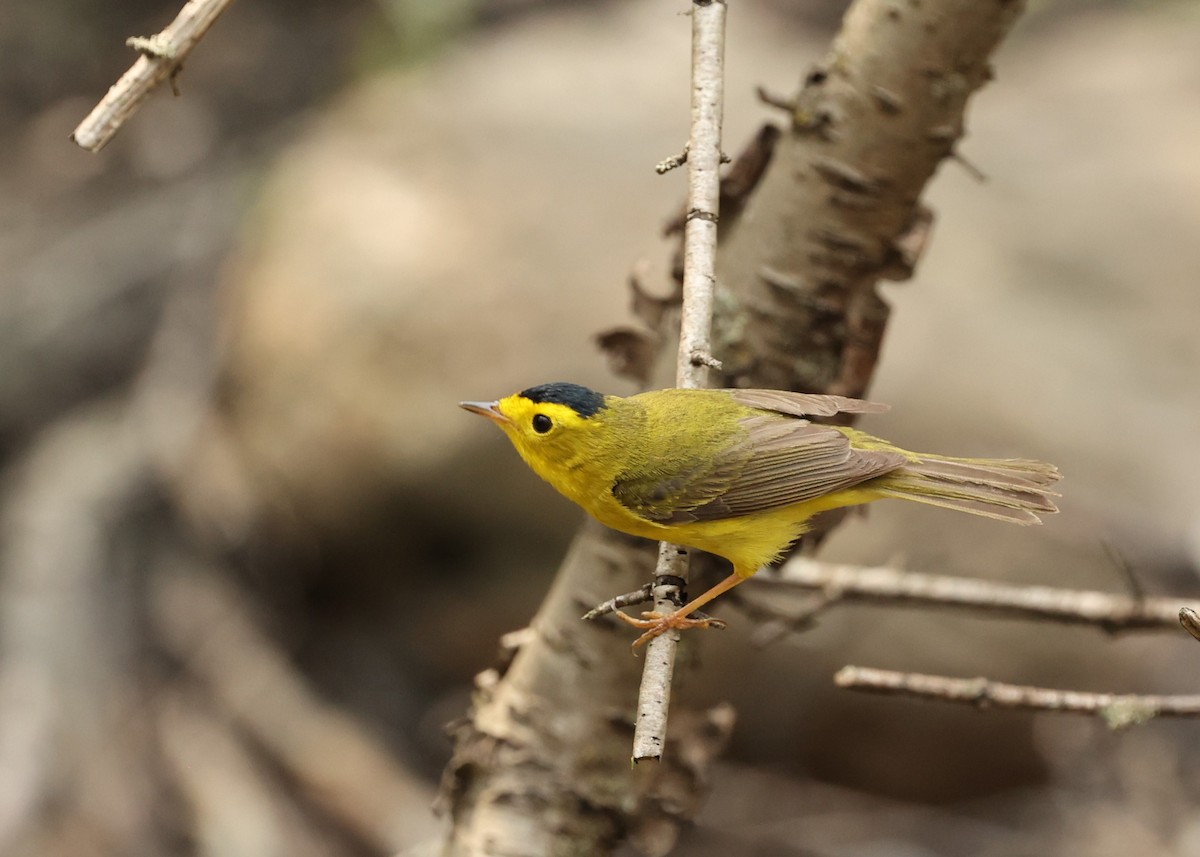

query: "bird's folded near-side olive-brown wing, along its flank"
xmin=612 ymin=414 xmax=905 ymax=523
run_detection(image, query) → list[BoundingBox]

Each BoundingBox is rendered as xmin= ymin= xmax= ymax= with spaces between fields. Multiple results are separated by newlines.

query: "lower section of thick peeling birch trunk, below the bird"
xmin=440 ymin=523 xmax=733 ymax=857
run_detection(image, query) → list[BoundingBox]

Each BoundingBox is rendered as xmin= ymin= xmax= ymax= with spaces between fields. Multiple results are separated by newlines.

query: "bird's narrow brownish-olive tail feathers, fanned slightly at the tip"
xmin=871 ymin=454 xmax=1060 ymax=525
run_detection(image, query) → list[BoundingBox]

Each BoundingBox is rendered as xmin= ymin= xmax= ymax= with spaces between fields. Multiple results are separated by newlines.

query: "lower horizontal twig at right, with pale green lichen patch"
xmin=833 ymin=666 xmax=1200 ymax=729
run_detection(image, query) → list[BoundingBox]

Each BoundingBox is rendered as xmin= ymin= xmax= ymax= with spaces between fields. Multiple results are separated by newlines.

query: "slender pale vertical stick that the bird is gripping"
xmin=634 ymin=0 xmax=725 ymax=762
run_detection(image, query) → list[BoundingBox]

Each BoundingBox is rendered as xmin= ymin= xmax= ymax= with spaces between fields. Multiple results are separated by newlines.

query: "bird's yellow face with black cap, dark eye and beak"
xmin=461 ymin=384 xmax=607 ymax=487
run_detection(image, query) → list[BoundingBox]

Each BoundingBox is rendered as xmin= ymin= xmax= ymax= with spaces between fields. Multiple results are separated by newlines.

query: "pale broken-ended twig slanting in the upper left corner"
xmin=71 ymin=0 xmax=233 ymax=151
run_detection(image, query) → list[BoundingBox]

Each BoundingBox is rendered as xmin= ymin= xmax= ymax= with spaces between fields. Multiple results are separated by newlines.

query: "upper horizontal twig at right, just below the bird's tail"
xmin=748 ymin=557 xmax=1200 ymax=634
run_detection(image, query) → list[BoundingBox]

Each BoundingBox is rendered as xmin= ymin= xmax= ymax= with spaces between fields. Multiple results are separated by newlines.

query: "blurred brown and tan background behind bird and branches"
xmin=0 ymin=0 xmax=1200 ymax=857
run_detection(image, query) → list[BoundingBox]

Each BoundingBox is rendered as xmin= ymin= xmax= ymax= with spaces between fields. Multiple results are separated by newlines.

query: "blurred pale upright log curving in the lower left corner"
xmin=0 ymin=401 xmax=160 ymax=855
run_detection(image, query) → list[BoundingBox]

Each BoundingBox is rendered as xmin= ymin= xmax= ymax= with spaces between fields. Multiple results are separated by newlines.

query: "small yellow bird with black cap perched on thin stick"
xmin=461 ymin=383 xmax=1058 ymax=647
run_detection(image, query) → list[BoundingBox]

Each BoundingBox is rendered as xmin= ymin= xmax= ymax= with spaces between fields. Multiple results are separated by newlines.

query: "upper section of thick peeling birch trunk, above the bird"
xmin=718 ymin=0 xmax=1024 ymax=396
